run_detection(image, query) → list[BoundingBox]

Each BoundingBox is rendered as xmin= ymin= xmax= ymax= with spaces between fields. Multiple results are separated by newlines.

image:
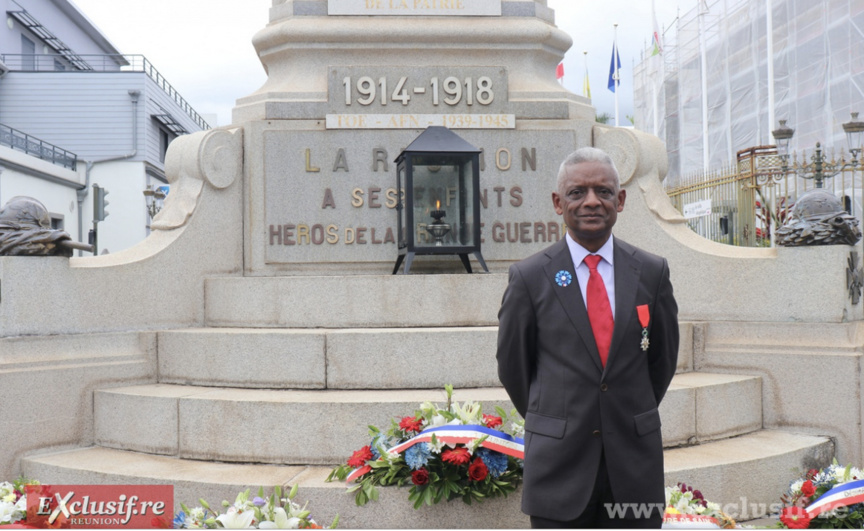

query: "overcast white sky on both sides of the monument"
xmin=73 ymin=0 xmax=684 ymax=125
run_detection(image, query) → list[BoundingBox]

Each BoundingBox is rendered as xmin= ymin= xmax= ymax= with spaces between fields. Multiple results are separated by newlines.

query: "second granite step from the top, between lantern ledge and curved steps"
xmin=158 ymin=323 xmax=693 ymax=389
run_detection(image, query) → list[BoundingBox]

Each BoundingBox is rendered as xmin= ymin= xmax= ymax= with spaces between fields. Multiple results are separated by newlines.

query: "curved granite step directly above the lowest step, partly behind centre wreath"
xmin=94 ymin=373 xmax=762 ymax=464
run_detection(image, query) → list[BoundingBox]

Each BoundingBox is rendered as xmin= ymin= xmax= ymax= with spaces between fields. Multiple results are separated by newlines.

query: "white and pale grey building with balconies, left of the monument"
xmin=0 ymin=0 xmax=209 ymax=254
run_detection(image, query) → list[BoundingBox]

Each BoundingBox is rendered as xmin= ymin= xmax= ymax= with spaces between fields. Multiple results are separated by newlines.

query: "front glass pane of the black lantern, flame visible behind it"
xmin=411 ymin=155 xmax=475 ymax=247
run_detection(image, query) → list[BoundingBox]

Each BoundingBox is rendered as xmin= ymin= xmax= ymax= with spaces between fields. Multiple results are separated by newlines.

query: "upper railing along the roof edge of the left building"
xmin=0 ymin=54 xmax=210 ymax=129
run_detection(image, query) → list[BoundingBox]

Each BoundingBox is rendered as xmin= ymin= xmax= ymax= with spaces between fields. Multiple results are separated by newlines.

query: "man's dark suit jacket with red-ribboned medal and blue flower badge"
xmin=497 ymin=238 xmax=678 ymax=523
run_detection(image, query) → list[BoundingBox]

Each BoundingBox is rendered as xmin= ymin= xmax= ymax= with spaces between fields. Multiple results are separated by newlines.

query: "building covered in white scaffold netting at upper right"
xmin=634 ymin=0 xmax=864 ymax=183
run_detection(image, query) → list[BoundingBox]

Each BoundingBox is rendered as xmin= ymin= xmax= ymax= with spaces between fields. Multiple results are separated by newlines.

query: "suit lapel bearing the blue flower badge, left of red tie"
xmin=544 ymin=238 xmax=604 ymax=371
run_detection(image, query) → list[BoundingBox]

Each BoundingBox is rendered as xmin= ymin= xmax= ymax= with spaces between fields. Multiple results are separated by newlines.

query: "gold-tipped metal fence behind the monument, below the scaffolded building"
xmin=666 ymin=146 xmax=864 ymax=247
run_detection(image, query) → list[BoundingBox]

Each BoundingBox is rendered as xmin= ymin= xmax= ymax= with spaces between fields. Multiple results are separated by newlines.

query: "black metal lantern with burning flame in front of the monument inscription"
xmin=393 ymin=126 xmax=489 ymax=275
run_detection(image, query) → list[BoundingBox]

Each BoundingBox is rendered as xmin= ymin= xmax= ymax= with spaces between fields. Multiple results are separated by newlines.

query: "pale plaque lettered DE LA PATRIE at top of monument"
xmin=327 ymin=0 xmax=501 ymax=17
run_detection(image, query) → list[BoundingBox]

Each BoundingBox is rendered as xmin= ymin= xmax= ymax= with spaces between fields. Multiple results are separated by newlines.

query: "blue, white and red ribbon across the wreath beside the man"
xmin=345 ymin=424 xmax=525 ymax=483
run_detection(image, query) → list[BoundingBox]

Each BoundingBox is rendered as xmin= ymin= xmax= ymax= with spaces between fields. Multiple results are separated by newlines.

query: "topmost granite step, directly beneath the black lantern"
xmin=204 ymin=274 xmax=507 ymax=328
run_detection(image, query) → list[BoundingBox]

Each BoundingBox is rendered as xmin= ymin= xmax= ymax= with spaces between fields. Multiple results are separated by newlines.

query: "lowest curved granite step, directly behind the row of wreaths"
xmin=22 ymin=430 xmax=834 ymax=529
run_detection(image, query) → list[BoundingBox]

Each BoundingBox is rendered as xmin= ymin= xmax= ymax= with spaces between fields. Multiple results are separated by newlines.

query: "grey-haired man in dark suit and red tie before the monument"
xmin=497 ymin=147 xmax=678 ymax=528
